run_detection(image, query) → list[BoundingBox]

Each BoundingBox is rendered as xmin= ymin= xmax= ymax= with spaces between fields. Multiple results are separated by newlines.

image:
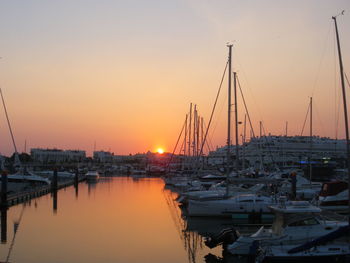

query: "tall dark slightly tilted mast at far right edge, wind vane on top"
xmin=332 ymin=10 xmax=350 ymax=225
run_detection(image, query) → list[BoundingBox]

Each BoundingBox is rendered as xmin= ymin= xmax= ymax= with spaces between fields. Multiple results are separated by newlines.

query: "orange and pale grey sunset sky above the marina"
xmin=0 ymin=0 xmax=350 ymax=155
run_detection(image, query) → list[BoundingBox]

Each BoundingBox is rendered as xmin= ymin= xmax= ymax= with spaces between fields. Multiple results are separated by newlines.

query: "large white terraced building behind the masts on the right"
xmin=208 ymin=135 xmax=346 ymax=167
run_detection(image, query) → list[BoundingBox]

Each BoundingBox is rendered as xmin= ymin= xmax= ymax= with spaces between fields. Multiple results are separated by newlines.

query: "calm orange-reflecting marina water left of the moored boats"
xmin=0 ymin=177 xmax=222 ymax=263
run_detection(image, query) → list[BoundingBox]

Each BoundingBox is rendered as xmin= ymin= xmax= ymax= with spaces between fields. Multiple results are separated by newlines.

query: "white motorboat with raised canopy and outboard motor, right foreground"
xmin=228 ymin=201 xmax=347 ymax=255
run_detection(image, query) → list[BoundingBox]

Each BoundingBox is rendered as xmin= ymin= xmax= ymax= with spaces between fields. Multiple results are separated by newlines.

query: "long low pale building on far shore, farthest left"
xmin=30 ymin=148 xmax=86 ymax=163
